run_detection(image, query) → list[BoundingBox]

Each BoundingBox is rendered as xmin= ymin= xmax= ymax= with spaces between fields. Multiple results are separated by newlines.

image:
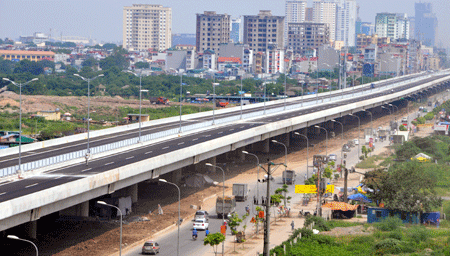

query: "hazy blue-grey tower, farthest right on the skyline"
xmin=414 ymin=3 xmax=438 ymax=46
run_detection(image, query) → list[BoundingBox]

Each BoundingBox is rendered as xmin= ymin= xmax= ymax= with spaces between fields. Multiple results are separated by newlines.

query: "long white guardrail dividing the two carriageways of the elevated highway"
xmin=0 ymin=75 xmax=442 ymax=177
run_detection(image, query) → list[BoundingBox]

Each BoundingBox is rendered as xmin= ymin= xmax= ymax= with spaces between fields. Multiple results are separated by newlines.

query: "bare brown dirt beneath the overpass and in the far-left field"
xmin=0 ymin=92 xmax=432 ymax=256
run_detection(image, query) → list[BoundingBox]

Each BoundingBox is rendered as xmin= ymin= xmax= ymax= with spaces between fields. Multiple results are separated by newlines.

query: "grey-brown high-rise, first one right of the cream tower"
xmin=196 ymin=11 xmax=230 ymax=54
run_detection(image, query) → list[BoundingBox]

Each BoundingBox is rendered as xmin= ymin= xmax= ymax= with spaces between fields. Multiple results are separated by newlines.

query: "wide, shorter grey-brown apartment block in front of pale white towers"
xmin=286 ymin=22 xmax=330 ymax=55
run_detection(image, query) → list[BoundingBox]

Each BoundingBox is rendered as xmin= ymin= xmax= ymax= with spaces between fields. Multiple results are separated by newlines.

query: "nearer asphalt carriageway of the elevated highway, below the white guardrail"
xmin=0 ymin=74 xmax=446 ymax=202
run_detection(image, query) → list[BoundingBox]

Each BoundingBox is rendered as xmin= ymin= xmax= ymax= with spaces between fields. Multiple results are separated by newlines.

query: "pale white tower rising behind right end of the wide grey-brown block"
xmin=313 ymin=1 xmax=336 ymax=41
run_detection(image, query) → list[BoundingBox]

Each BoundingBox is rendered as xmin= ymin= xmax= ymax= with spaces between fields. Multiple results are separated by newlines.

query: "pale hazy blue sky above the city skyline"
xmin=0 ymin=0 xmax=450 ymax=47
